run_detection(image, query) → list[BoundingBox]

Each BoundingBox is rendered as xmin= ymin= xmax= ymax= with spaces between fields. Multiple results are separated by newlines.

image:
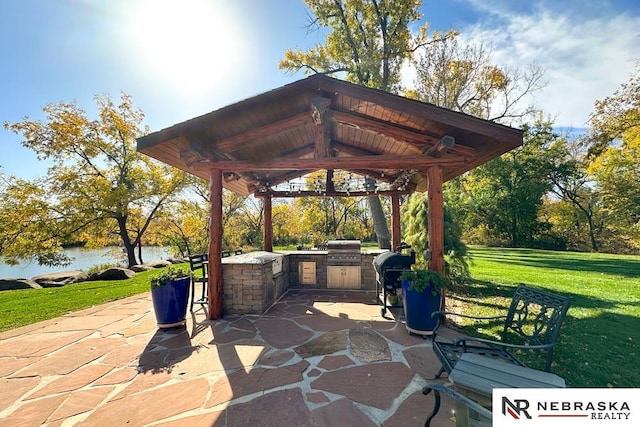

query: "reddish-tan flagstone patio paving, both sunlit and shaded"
xmin=0 ymin=290 xmax=460 ymax=427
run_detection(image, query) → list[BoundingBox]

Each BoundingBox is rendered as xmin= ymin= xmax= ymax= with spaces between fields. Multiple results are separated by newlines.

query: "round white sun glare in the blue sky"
xmin=133 ymin=0 xmax=238 ymax=92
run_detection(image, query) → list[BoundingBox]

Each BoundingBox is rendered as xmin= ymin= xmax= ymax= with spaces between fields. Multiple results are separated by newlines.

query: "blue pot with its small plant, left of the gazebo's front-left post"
xmin=151 ymin=266 xmax=191 ymax=328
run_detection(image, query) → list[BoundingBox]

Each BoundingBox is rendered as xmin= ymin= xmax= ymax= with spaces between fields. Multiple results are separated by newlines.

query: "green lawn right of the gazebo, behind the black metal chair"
xmin=450 ymin=247 xmax=640 ymax=387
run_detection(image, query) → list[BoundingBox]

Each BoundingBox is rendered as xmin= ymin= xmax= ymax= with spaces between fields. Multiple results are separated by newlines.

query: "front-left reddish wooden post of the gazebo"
xmin=208 ymin=169 xmax=223 ymax=320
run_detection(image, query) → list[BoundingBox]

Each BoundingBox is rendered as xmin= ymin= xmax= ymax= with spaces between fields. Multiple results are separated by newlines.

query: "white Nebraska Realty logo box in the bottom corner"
xmin=492 ymin=388 xmax=640 ymax=427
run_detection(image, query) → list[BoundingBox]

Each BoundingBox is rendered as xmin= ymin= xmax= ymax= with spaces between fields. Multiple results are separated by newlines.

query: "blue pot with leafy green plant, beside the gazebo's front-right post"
xmin=400 ymin=269 xmax=451 ymax=336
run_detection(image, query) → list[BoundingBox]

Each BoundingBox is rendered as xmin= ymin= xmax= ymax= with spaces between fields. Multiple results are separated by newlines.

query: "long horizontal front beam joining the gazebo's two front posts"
xmin=189 ymin=155 xmax=467 ymax=172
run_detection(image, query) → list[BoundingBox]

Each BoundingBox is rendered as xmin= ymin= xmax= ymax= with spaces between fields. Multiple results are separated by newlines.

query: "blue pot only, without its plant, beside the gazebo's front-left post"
xmin=151 ymin=276 xmax=191 ymax=328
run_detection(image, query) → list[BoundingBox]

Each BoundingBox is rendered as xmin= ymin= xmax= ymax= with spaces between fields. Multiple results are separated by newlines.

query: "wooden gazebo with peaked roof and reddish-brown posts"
xmin=138 ymin=74 xmax=522 ymax=319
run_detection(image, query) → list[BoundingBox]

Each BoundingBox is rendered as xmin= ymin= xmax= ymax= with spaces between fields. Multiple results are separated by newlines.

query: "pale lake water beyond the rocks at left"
xmin=0 ymin=246 xmax=169 ymax=279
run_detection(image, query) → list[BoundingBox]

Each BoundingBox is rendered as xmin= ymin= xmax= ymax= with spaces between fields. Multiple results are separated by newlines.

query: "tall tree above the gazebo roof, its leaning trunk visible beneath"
xmin=278 ymin=0 xmax=455 ymax=248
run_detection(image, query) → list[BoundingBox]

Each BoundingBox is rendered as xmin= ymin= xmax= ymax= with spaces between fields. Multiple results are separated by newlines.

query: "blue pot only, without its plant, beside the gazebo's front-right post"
xmin=402 ymin=280 xmax=442 ymax=335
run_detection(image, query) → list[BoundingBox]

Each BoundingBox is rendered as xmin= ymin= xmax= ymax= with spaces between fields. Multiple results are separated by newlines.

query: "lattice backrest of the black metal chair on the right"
xmin=502 ymin=285 xmax=571 ymax=352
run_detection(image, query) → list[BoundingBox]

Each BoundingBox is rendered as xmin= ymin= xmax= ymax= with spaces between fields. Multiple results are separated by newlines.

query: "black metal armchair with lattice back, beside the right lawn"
xmin=433 ymin=285 xmax=571 ymax=378
